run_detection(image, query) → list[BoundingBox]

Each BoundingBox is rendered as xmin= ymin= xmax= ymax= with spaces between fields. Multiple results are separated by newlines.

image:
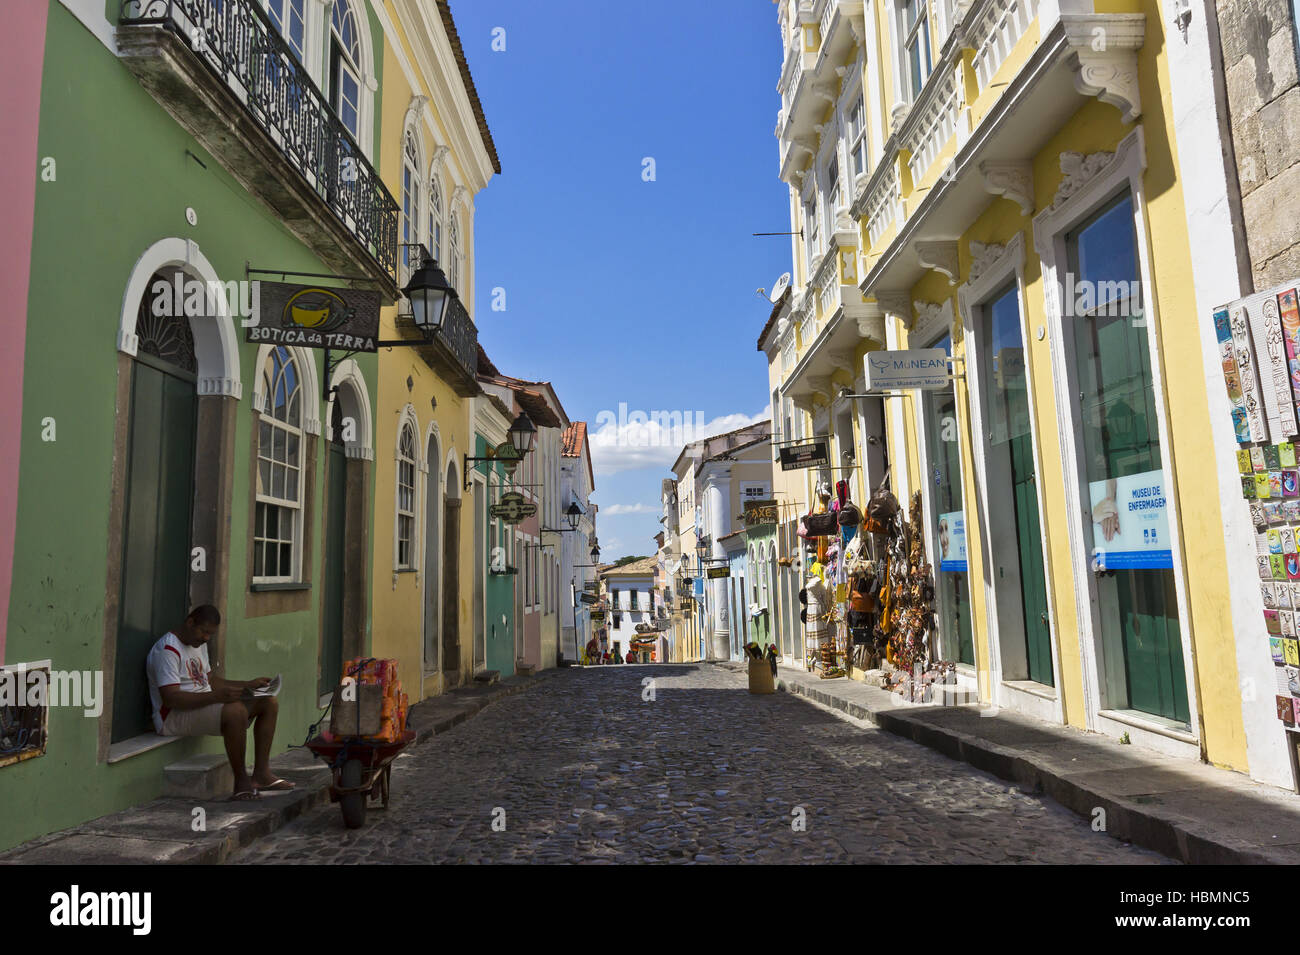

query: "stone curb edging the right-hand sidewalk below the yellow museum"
xmin=723 ymin=661 xmax=1292 ymax=865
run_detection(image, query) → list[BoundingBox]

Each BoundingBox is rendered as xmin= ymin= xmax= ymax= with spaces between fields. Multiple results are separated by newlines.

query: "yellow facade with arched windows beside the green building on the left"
xmin=372 ymin=0 xmax=501 ymax=700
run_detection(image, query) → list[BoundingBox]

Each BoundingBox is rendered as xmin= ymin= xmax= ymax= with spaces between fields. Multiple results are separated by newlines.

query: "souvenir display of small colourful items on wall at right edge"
xmin=1214 ymin=283 xmax=1300 ymax=733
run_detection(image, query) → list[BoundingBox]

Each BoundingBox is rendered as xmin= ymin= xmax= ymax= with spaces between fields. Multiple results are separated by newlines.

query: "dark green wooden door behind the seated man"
xmin=113 ymin=353 xmax=195 ymax=743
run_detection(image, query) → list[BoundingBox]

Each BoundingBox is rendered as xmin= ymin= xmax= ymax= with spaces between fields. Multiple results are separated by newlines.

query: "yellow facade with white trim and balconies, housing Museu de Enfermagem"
xmin=758 ymin=0 xmax=1283 ymax=782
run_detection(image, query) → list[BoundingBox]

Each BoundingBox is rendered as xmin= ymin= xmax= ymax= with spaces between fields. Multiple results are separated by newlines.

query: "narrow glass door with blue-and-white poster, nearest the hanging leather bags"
xmin=920 ymin=337 xmax=975 ymax=665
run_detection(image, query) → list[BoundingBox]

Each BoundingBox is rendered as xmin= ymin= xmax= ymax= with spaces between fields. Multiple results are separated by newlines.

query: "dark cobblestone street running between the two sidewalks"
xmin=233 ymin=665 xmax=1166 ymax=863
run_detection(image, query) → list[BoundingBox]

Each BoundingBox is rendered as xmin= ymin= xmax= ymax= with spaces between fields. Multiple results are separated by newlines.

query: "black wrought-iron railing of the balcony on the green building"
xmin=120 ymin=0 xmax=398 ymax=281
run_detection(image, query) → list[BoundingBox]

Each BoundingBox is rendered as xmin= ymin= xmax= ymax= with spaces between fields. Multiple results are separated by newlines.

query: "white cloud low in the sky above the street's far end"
xmin=590 ymin=403 xmax=772 ymax=478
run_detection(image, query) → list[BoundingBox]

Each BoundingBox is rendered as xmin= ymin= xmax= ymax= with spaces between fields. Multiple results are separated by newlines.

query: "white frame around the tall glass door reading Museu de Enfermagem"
xmin=1034 ymin=126 xmax=1200 ymax=756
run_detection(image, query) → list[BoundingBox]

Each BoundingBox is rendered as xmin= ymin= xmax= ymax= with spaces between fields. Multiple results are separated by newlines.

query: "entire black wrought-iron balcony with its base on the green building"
xmin=116 ymin=0 xmax=398 ymax=300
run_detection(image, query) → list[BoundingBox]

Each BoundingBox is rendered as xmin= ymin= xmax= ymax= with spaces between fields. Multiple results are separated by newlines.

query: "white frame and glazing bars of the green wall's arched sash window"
xmin=252 ymin=346 xmax=311 ymax=583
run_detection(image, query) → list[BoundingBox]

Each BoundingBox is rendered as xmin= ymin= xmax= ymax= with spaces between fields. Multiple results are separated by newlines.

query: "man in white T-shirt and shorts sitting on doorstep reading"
xmin=146 ymin=604 xmax=294 ymax=799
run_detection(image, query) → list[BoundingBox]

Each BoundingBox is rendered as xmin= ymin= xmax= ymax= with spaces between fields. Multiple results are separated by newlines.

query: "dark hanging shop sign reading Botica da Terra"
xmin=244 ymin=282 xmax=380 ymax=352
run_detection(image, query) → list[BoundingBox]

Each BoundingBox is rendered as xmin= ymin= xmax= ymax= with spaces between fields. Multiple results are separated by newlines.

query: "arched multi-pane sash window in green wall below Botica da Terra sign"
xmin=252 ymin=346 xmax=303 ymax=583
